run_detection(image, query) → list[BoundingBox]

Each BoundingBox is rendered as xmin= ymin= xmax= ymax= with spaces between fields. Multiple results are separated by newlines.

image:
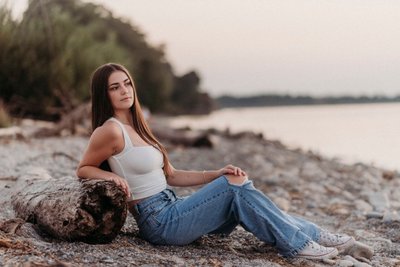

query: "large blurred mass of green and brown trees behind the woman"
xmin=0 ymin=0 xmax=210 ymax=120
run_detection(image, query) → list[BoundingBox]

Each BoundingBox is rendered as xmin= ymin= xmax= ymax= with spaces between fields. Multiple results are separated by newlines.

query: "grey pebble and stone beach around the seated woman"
xmin=0 ymin=120 xmax=400 ymax=267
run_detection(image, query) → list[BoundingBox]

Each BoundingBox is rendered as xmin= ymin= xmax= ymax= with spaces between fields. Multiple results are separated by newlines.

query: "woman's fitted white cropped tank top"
xmin=108 ymin=117 xmax=167 ymax=200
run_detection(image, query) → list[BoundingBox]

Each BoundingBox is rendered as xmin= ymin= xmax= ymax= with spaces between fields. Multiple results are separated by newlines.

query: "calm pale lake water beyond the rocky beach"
xmin=171 ymin=103 xmax=400 ymax=170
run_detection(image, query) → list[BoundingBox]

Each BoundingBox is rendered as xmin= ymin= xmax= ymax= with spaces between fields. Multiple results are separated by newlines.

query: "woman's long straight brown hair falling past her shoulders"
xmin=90 ymin=63 xmax=172 ymax=176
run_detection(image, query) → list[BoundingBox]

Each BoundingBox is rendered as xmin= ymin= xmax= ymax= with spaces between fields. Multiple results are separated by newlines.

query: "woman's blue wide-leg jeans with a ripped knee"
xmin=134 ymin=176 xmax=320 ymax=257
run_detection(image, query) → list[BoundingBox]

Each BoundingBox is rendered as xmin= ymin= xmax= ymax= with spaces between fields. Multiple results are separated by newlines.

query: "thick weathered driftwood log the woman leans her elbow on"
xmin=11 ymin=170 xmax=127 ymax=243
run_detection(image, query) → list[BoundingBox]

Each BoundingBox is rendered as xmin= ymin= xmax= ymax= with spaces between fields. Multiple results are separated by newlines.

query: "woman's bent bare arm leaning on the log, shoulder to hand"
xmin=76 ymin=124 xmax=130 ymax=196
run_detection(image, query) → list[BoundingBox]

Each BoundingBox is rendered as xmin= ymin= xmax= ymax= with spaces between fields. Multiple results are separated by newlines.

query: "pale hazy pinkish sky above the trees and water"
xmin=7 ymin=0 xmax=400 ymax=96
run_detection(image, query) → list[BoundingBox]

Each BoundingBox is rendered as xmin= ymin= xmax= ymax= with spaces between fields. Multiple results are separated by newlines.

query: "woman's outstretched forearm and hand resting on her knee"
xmin=167 ymin=165 xmax=246 ymax=187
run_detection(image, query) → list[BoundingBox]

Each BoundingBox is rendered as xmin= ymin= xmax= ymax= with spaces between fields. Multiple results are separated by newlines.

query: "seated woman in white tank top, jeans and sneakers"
xmin=77 ymin=63 xmax=354 ymax=259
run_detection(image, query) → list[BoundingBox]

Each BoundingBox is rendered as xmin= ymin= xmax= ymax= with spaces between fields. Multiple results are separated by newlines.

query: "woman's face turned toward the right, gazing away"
xmin=108 ymin=71 xmax=134 ymax=111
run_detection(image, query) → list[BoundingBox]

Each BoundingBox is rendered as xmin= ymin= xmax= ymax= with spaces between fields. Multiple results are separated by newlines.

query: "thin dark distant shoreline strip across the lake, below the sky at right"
xmin=215 ymin=94 xmax=400 ymax=108
